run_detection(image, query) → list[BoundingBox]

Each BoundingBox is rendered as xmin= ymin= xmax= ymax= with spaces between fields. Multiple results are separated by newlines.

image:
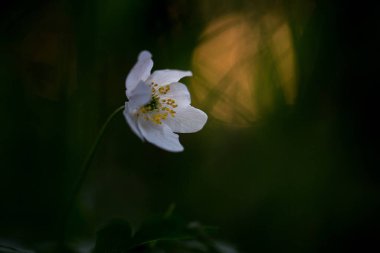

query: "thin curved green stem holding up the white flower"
xmin=63 ymin=105 xmax=124 ymax=234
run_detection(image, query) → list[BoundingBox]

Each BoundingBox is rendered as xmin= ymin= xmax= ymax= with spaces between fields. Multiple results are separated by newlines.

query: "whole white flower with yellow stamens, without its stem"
xmin=124 ymin=51 xmax=207 ymax=152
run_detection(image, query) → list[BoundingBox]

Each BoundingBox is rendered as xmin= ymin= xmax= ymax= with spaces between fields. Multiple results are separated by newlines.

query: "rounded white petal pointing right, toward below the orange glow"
xmin=165 ymin=106 xmax=207 ymax=133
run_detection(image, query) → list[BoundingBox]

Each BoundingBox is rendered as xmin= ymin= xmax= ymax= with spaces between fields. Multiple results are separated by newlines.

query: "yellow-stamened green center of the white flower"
xmin=137 ymin=82 xmax=178 ymax=125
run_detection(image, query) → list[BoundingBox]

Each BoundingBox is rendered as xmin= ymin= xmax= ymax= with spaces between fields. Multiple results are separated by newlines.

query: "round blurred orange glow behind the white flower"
xmin=191 ymin=11 xmax=296 ymax=126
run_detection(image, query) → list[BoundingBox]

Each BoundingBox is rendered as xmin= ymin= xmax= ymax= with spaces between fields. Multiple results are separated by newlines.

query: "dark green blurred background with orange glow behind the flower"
xmin=0 ymin=0 xmax=380 ymax=252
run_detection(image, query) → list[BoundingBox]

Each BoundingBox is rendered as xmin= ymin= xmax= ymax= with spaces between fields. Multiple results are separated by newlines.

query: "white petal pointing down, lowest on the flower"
xmin=138 ymin=117 xmax=183 ymax=152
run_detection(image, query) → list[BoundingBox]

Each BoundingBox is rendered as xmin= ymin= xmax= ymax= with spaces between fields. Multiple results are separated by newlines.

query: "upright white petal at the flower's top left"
xmin=125 ymin=51 xmax=153 ymax=95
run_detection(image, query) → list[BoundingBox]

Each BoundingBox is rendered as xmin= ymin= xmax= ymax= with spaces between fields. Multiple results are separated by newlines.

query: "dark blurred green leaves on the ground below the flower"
xmin=95 ymin=216 xmax=220 ymax=253
